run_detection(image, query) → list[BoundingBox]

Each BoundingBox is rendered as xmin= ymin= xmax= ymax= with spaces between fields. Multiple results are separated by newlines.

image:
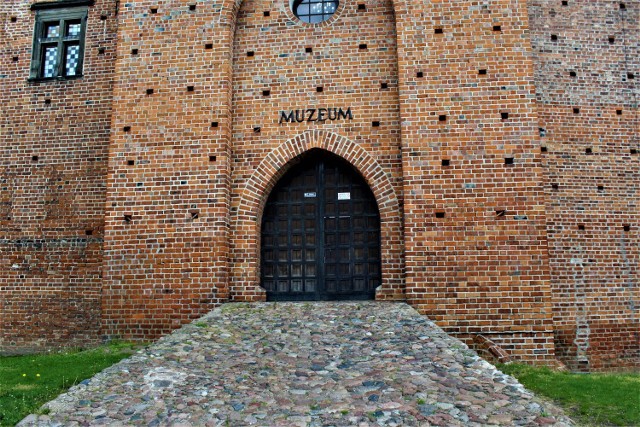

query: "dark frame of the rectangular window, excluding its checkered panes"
xmin=29 ymin=0 xmax=93 ymax=81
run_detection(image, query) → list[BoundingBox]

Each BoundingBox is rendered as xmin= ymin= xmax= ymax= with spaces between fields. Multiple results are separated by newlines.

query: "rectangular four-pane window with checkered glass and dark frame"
xmin=30 ymin=0 xmax=90 ymax=80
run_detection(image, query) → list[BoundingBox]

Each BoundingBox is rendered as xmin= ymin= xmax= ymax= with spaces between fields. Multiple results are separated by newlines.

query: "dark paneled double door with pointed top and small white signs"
xmin=260 ymin=150 xmax=381 ymax=301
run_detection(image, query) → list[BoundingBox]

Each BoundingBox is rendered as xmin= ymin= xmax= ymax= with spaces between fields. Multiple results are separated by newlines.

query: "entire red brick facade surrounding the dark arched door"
xmin=0 ymin=0 xmax=640 ymax=370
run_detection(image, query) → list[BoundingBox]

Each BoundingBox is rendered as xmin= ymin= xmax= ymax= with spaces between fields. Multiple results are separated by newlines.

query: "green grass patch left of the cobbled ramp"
xmin=0 ymin=343 xmax=136 ymax=426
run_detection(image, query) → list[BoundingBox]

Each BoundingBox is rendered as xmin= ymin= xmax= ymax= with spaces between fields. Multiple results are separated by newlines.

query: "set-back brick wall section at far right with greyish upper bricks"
xmin=529 ymin=0 xmax=640 ymax=370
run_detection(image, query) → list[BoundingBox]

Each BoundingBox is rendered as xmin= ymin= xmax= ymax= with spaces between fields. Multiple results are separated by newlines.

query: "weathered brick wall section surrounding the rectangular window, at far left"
xmin=0 ymin=0 xmax=117 ymax=352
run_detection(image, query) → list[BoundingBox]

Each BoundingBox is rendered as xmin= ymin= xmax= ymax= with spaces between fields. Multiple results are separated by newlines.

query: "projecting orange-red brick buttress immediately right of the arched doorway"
xmin=396 ymin=1 xmax=554 ymax=361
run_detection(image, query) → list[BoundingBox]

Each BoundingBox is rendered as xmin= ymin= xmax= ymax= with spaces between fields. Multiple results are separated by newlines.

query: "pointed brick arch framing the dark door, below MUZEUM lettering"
xmin=230 ymin=130 xmax=404 ymax=301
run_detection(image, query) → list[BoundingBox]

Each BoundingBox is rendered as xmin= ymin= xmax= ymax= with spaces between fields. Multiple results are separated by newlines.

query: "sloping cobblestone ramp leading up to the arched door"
xmin=19 ymin=302 xmax=571 ymax=426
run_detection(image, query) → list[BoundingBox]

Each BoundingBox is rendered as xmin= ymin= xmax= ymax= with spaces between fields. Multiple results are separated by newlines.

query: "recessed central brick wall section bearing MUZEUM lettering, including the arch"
xmin=231 ymin=0 xmax=404 ymax=299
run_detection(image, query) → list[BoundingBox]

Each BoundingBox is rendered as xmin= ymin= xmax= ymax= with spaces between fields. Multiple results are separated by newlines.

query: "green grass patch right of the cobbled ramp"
xmin=499 ymin=363 xmax=640 ymax=426
